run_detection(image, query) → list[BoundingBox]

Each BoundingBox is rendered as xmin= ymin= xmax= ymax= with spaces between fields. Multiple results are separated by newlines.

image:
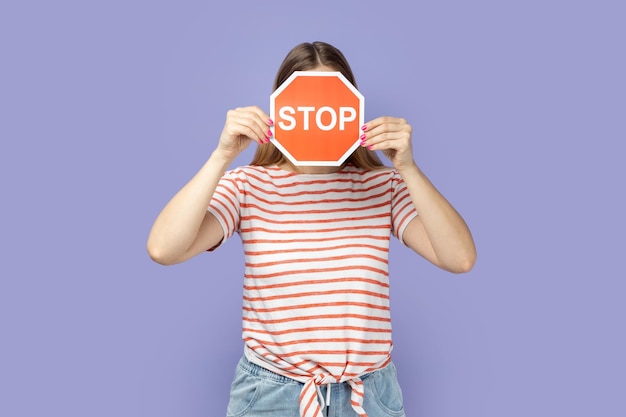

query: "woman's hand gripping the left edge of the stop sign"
xmin=216 ymin=106 xmax=273 ymax=161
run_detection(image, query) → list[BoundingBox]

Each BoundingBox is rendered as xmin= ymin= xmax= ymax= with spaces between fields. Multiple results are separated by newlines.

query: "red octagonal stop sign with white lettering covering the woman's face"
xmin=270 ymin=71 xmax=365 ymax=166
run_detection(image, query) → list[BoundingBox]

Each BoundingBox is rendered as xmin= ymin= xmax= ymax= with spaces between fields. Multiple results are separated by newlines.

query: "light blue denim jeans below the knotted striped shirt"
xmin=226 ymin=356 xmax=405 ymax=417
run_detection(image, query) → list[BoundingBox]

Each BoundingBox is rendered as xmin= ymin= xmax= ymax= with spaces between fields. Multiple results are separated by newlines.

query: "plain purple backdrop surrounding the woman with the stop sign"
xmin=0 ymin=0 xmax=626 ymax=417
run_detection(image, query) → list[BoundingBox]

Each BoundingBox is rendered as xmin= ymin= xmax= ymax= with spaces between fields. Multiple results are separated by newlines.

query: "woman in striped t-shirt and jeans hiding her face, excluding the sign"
xmin=147 ymin=42 xmax=476 ymax=417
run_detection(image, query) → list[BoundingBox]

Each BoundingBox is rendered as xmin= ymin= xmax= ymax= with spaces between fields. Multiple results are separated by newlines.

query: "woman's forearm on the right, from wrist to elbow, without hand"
xmin=399 ymin=164 xmax=476 ymax=272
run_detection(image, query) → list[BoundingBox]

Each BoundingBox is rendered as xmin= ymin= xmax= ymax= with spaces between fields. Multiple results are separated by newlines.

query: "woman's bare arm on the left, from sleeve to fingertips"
xmin=147 ymin=107 xmax=271 ymax=265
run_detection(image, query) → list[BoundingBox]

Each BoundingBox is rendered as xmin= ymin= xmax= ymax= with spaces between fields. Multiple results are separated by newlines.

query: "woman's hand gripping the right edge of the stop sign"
xmin=361 ymin=116 xmax=415 ymax=171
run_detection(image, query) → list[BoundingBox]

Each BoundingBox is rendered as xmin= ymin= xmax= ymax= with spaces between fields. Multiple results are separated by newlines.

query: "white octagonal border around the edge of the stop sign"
xmin=270 ymin=71 xmax=365 ymax=166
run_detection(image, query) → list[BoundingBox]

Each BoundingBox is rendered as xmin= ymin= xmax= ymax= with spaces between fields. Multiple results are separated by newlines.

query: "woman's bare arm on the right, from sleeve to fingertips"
xmin=362 ymin=117 xmax=476 ymax=273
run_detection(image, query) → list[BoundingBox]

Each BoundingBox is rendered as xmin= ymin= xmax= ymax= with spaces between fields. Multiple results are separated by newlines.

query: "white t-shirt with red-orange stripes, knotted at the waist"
xmin=209 ymin=165 xmax=417 ymax=416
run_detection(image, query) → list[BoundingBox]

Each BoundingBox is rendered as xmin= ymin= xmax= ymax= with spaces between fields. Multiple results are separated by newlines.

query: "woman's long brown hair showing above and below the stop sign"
xmin=250 ymin=42 xmax=384 ymax=169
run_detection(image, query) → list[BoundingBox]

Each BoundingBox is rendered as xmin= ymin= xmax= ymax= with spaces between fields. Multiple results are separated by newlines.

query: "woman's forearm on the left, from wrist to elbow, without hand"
xmin=147 ymin=152 xmax=231 ymax=263
